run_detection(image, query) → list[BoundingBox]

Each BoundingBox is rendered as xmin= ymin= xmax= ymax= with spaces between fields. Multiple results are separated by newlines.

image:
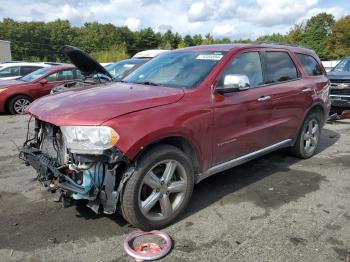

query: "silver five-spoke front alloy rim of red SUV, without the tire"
xmin=139 ymin=160 xmax=187 ymax=221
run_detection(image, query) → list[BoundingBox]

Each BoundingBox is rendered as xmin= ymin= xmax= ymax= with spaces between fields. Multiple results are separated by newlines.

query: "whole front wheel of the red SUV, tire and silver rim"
xmin=120 ymin=145 xmax=194 ymax=230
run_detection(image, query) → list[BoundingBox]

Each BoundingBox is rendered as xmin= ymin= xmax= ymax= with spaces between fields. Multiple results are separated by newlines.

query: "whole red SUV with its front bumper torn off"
xmin=21 ymin=44 xmax=330 ymax=230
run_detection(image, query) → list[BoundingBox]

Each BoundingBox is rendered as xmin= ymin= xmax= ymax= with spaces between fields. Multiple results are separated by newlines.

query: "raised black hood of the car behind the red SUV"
xmin=61 ymin=45 xmax=113 ymax=78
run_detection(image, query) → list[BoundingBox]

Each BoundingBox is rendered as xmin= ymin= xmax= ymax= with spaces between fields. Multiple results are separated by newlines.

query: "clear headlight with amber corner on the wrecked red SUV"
xmin=61 ymin=126 xmax=119 ymax=154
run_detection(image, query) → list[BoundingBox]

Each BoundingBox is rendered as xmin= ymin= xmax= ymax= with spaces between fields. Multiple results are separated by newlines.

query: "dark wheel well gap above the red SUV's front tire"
xmin=136 ymin=136 xmax=199 ymax=172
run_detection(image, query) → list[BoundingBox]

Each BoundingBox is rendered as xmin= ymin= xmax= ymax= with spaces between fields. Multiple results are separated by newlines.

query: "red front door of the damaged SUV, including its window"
xmin=213 ymin=50 xmax=272 ymax=164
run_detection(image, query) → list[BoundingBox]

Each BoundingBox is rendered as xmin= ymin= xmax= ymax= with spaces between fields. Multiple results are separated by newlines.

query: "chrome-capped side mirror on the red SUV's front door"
xmin=215 ymin=75 xmax=250 ymax=94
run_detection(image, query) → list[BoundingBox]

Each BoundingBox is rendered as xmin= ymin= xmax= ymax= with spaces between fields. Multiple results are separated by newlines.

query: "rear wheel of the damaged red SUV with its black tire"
xmin=290 ymin=113 xmax=322 ymax=159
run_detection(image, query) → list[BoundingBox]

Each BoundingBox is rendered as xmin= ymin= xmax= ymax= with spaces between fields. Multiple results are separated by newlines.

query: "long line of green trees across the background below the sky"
xmin=0 ymin=13 xmax=350 ymax=62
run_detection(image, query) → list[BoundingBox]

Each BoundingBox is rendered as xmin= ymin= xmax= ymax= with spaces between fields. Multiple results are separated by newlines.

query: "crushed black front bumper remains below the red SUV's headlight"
xmin=19 ymin=142 xmax=134 ymax=214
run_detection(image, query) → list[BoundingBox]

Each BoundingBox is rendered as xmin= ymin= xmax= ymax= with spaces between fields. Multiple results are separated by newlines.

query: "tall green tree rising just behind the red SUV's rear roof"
xmin=301 ymin=13 xmax=335 ymax=59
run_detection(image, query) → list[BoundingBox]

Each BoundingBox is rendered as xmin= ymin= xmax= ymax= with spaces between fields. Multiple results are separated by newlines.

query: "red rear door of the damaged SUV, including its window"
xmin=262 ymin=50 xmax=314 ymax=143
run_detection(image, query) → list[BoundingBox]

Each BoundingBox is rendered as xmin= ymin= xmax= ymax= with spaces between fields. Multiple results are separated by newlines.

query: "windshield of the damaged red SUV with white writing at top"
xmin=124 ymin=51 xmax=226 ymax=88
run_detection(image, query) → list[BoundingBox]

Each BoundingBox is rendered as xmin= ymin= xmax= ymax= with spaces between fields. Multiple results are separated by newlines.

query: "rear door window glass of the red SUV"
xmin=264 ymin=52 xmax=298 ymax=84
